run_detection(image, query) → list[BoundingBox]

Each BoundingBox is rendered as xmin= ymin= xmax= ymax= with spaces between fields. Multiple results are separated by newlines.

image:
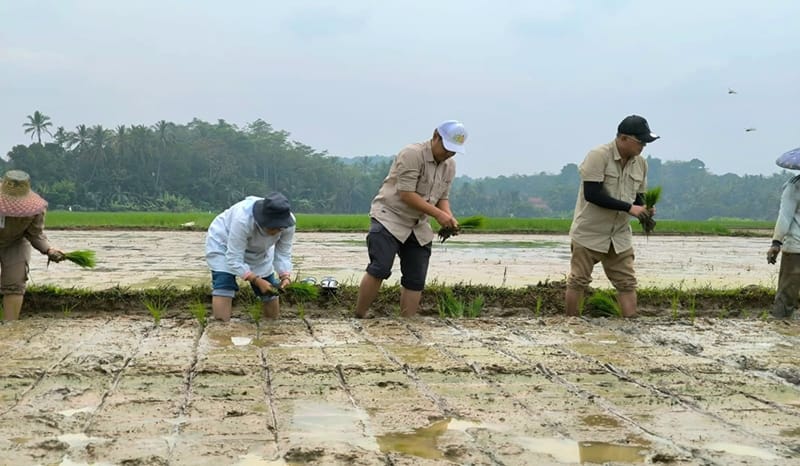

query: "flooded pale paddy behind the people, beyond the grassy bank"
xmin=31 ymin=231 xmax=778 ymax=289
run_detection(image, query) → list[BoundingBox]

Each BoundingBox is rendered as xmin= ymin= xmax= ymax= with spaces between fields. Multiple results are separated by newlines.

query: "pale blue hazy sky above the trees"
xmin=0 ymin=0 xmax=800 ymax=177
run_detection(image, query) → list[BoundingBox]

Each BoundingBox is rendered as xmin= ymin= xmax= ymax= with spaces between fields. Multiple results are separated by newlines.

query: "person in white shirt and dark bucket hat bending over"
xmin=206 ymin=192 xmax=296 ymax=321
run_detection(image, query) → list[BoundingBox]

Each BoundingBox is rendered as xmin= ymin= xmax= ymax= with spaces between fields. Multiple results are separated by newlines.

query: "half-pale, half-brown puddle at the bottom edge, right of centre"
xmin=515 ymin=437 xmax=647 ymax=464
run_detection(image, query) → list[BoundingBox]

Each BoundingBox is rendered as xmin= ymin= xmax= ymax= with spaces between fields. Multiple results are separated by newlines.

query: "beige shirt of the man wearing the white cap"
xmin=369 ymin=141 xmax=456 ymax=245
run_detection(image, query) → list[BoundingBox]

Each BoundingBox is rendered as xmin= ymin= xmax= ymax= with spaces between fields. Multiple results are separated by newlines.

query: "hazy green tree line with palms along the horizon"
xmin=6 ymin=111 xmax=791 ymax=220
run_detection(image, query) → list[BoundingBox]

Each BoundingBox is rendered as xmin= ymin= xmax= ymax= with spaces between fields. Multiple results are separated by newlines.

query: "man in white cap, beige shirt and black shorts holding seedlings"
xmin=355 ymin=120 xmax=467 ymax=318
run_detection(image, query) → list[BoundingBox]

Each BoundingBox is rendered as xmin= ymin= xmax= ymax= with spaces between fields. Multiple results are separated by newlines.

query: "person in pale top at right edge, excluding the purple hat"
xmin=767 ymin=175 xmax=800 ymax=319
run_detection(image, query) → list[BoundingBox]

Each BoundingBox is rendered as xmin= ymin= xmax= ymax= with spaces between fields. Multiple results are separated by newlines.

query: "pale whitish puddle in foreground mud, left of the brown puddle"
xmin=290 ymin=400 xmax=378 ymax=451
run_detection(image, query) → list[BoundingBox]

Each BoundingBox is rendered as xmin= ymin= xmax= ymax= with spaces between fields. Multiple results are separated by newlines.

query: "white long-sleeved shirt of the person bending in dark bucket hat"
xmin=206 ymin=196 xmax=295 ymax=277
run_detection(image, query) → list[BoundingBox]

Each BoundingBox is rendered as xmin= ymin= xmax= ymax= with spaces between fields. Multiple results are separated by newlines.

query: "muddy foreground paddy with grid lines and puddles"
xmin=0 ymin=312 xmax=800 ymax=466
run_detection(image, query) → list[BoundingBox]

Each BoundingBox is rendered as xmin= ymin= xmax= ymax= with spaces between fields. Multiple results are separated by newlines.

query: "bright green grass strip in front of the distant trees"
xmin=40 ymin=210 xmax=774 ymax=236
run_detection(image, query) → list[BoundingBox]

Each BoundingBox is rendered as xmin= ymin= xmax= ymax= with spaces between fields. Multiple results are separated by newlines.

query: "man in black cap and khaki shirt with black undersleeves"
xmin=565 ymin=115 xmax=659 ymax=317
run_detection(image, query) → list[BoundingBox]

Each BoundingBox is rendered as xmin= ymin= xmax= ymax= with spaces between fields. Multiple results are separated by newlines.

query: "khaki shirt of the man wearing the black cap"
xmin=569 ymin=141 xmax=647 ymax=252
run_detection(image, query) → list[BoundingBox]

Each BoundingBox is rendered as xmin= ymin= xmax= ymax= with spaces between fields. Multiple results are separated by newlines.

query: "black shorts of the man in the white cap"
xmin=367 ymin=218 xmax=432 ymax=291
